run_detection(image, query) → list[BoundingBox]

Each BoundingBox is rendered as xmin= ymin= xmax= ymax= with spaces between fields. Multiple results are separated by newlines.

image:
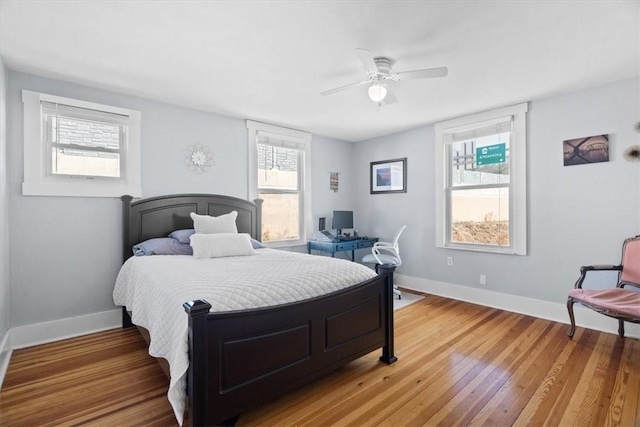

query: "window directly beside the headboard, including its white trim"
xmin=247 ymin=120 xmax=311 ymax=246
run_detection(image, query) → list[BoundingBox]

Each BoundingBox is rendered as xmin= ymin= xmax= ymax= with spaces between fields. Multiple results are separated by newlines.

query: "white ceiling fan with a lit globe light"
xmin=320 ymin=48 xmax=449 ymax=105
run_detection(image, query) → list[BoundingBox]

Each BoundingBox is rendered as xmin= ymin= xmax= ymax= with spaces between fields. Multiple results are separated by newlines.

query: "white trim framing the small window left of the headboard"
xmin=22 ymin=90 xmax=142 ymax=197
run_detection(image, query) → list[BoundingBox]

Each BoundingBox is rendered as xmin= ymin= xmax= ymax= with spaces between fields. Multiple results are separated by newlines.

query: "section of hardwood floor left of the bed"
xmin=0 ymin=328 xmax=176 ymax=426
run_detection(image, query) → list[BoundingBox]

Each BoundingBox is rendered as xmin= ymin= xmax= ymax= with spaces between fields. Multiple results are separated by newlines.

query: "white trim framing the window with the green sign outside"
xmin=434 ymin=102 xmax=528 ymax=255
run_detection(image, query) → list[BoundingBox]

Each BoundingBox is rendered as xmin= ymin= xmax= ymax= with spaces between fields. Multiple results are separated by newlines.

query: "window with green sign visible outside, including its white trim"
xmin=435 ymin=104 xmax=527 ymax=255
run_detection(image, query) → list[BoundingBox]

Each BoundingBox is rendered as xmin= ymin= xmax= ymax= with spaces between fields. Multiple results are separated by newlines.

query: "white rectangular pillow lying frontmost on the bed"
xmin=191 ymin=233 xmax=256 ymax=258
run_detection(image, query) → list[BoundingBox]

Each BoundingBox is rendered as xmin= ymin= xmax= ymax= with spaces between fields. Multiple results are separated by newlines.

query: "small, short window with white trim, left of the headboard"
xmin=22 ymin=90 xmax=141 ymax=197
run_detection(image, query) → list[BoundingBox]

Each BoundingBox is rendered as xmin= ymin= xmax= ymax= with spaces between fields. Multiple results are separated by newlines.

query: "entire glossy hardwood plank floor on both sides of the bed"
xmin=0 ymin=296 xmax=640 ymax=426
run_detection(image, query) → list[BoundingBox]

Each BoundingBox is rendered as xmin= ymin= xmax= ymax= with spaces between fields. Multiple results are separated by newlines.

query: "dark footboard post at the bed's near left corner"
xmin=182 ymin=300 xmax=211 ymax=426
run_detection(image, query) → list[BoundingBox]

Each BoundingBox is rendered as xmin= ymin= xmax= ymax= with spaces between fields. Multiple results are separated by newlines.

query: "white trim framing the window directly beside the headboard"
xmin=247 ymin=120 xmax=313 ymax=247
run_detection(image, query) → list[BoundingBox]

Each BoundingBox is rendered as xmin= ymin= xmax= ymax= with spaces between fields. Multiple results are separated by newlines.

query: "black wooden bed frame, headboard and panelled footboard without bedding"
xmin=115 ymin=194 xmax=397 ymax=425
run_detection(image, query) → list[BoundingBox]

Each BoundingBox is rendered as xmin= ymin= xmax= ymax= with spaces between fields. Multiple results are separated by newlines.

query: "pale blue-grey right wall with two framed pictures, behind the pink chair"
xmin=354 ymin=79 xmax=640 ymax=303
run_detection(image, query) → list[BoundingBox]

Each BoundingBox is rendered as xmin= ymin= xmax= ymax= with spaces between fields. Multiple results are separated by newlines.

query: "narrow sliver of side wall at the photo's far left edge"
xmin=0 ymin=57 xmax=11 ymax=344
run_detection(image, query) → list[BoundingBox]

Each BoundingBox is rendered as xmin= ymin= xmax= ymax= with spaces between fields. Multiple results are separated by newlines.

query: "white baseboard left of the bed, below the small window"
xmin=9 ymin=309 xmax=122 ymax=350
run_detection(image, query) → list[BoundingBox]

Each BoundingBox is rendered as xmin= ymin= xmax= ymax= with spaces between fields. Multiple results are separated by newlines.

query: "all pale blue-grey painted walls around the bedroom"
xmin=6 ymin=67 xmax=640 ymax=333
